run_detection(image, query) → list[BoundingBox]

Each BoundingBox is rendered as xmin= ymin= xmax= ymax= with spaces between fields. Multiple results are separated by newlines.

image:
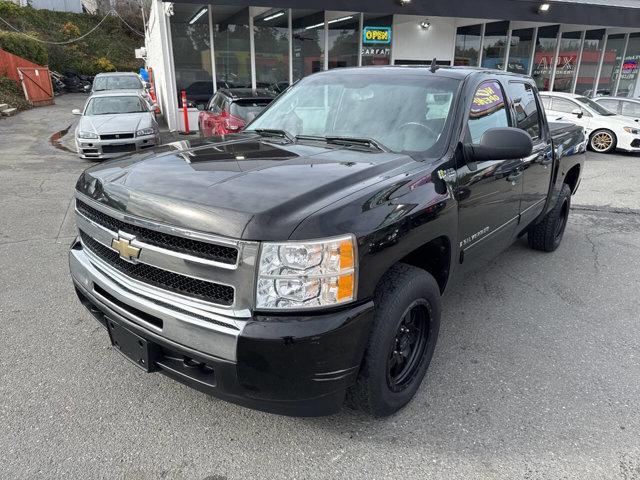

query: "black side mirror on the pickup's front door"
xmin=463 ymin=127 xmax=533 ymax=162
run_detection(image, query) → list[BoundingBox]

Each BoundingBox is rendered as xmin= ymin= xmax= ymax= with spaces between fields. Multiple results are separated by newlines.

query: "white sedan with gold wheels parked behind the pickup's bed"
xmin=540 ymin=92 xmax=640 ymax=153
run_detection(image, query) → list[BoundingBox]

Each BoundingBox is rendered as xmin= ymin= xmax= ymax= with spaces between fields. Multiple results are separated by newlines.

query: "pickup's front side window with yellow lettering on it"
xmin=467 ymin=80 xmax=509 ymax=143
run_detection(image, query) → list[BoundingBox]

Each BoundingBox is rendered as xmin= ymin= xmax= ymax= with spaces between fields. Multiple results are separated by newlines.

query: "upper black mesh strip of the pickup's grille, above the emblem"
xmin=76 ymin=200 xmax=238 ymax=265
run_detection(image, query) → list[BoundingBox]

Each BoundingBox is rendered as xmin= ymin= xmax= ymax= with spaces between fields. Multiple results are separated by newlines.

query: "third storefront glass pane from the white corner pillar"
xmin=253 ymin=9 xmax=289 ymax=91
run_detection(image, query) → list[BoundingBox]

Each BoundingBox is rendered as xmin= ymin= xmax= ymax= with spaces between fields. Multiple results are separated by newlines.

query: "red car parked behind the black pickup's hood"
xmin=198 ymin=88 xmax=277 ymax=138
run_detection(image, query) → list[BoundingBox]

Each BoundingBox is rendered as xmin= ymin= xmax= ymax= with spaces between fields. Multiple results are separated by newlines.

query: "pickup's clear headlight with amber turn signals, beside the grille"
xmin=256 ymin=235 xmax=356 ymax=309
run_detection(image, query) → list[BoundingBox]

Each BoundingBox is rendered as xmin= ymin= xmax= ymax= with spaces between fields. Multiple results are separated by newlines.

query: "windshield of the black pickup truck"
xmin=247 ymin=70 xmax=459 ymax=152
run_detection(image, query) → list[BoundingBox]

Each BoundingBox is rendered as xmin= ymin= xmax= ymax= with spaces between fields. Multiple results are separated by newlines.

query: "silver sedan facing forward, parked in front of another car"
xmin=72 ymin=90 xmax=160 ymax=159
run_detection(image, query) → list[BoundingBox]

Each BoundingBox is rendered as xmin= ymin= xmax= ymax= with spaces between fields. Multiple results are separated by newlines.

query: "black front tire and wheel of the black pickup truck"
xmin=347 ymin=264 xmax=441 ymax=417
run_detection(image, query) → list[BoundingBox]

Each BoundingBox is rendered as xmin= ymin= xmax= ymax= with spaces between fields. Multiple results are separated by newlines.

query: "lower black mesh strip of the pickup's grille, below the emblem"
xmin=80 ymin=231 xmax=234 ymax=306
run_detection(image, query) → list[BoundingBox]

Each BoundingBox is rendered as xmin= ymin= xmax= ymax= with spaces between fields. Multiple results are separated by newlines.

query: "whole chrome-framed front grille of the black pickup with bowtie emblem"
xmin=75 ymin=192 xmax=259 ymax=316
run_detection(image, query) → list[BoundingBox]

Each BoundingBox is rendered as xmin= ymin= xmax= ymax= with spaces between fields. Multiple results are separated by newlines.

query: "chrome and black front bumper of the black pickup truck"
xmin=69 ymin=242 xmax=373 ymax=416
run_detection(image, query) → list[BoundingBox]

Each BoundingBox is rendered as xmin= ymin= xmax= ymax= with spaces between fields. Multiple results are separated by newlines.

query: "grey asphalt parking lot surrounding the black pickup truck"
xmin=0 ymin=95 xmax=640 ymax=480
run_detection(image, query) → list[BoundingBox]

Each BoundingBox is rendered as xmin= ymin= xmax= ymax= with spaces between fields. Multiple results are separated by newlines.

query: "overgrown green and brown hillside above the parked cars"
xmin=0 ymin=0 xmax=144 ymax=75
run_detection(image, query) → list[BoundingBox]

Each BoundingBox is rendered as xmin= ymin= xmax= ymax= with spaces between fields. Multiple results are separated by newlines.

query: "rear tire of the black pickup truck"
xmin=527 ymin=183 xmax=571 ymax=252
